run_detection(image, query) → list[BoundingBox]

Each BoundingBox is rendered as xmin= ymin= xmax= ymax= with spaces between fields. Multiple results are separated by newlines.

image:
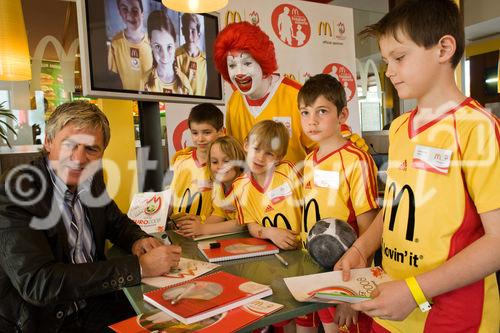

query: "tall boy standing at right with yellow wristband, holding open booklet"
xmin=336 ymin=0 xmax=500 ymax=333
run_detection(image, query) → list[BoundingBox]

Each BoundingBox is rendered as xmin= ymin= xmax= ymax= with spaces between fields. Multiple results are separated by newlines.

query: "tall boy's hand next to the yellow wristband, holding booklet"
xmin=352 ymin=280 xmax=417 ymax=320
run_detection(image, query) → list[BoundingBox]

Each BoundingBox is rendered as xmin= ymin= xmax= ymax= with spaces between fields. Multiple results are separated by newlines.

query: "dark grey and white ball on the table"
xmin=307 ymin=218 xmax=357 ymax=270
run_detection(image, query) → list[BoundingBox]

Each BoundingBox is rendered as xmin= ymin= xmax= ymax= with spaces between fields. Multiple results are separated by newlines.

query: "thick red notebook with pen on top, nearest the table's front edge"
xmin=144 ymin=271 xmax=273 ymax=324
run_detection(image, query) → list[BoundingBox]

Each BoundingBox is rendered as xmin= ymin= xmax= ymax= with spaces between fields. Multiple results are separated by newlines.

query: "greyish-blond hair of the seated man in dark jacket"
xmin=45 ymin=101 xmax=111 ymax=148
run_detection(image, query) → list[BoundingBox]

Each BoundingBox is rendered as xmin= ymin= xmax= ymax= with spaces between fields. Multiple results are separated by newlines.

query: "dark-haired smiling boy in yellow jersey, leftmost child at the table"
xmin=170 ymin=103 xmax=224 ymax=222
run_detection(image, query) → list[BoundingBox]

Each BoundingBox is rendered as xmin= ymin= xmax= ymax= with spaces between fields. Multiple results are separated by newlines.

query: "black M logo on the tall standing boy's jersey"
xmin=384 ymin=182 xmax=415 ymax=242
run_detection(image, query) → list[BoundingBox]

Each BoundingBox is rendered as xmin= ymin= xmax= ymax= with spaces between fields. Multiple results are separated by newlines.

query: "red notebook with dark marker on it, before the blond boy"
xmin=198 ymin=237 xmax=279 ymax=262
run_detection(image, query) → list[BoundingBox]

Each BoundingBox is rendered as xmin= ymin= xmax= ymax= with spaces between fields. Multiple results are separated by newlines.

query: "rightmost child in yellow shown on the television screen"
xmin=175 ymin=13 xmax=207 ymax=96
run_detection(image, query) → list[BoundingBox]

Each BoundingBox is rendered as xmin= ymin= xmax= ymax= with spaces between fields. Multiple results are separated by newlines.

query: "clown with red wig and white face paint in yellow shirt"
xmin=214 ymin=22 xmax=367 ymax=163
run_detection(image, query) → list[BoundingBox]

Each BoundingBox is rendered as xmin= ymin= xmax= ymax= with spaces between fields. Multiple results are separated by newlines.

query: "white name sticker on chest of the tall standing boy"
xmin=412 ymin=145 xmax=452 ymax=175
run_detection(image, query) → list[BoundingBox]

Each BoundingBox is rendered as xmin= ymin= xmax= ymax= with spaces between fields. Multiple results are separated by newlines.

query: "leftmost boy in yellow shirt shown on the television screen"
xmin=108 ymin=0 xmax=153 ymax=90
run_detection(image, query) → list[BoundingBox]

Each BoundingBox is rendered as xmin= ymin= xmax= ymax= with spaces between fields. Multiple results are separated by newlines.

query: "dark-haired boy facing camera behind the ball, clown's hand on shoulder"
xmin=298 ymin=74 xmax=378 ymax=333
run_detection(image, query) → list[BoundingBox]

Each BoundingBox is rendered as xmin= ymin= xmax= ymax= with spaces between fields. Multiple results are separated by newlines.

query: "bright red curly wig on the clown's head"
xmin=214 ymin=22 xmax=278 ymax=82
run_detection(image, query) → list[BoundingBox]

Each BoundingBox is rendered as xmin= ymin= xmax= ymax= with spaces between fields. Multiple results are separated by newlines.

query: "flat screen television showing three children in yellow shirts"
xmin=77 ymin=0 xmax=224 ymax=104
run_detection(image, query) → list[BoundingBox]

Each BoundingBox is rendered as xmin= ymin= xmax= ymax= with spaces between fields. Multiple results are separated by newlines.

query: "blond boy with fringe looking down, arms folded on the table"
xmin=233 ymin=120 xmax=302 ymax=250
